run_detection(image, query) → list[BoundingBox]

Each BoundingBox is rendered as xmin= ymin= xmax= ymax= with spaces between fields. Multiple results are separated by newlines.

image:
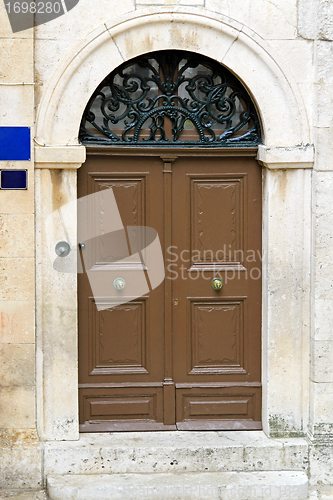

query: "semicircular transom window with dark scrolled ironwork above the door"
xmin=79 ymin=50 xmax=261 ymax=147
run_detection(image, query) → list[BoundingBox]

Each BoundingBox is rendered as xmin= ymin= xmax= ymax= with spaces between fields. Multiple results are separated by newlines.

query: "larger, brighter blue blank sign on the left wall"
xmin=0 ymin=127 xmax=31 ymax=161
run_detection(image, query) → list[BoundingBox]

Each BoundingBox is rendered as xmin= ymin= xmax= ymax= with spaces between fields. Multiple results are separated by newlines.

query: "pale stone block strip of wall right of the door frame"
xmin=298 ymin=0 xmax=333 ymax=488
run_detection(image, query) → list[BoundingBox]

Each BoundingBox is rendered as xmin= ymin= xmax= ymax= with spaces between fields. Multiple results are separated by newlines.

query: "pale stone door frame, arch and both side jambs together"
xmin=35 ymin=7 xmax=314 ymax=440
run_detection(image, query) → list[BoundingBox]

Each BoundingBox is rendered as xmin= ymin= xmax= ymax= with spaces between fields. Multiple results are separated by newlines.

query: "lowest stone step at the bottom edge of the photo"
xmin=47 ymin=471 xmax=308 ymax=500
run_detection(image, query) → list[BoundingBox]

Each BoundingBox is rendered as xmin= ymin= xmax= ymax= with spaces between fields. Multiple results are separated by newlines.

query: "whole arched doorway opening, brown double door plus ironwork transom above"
xmin=78 ymin=50 xmax=261 ymax=432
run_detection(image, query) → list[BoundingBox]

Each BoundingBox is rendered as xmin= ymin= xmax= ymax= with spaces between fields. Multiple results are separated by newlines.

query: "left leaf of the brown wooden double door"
xmin=78 ymin=156 xmax=164 ymax=432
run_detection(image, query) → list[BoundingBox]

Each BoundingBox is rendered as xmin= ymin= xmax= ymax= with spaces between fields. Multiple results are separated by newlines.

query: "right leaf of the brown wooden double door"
xmin=172 ymin=158 xmax=261 ymax=429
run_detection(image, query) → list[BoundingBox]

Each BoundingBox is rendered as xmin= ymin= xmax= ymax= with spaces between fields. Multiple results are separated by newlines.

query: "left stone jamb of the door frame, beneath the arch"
xmin=35 ymin=169 xmax=78 ymax=440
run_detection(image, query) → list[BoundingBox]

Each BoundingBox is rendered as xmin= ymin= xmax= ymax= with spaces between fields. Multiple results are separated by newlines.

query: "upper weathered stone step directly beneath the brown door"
xmin=44 ymin=431 xmax=308 ymax=476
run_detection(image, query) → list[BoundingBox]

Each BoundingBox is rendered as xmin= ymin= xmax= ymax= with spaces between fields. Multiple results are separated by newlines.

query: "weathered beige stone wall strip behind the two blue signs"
xmin=0 ymin=2 xmax=42 ymax=492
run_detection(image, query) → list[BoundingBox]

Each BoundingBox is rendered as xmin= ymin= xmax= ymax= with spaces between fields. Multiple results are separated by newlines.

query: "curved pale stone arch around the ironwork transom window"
xmin=36 ymin=7 xmax=310 ymax=147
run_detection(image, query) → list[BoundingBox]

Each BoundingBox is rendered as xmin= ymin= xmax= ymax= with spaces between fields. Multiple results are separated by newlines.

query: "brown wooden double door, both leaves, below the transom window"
xmin=78 ymin=150 xmax=261 ymax=432
